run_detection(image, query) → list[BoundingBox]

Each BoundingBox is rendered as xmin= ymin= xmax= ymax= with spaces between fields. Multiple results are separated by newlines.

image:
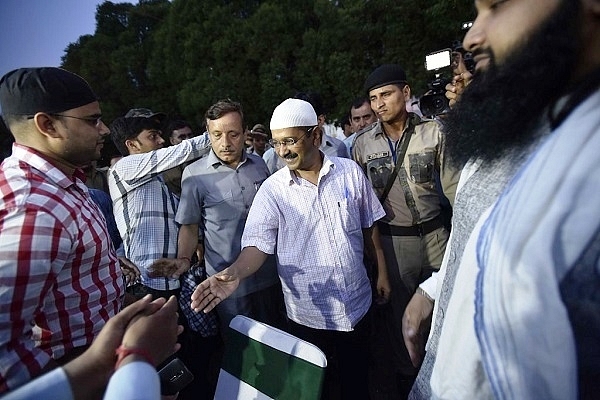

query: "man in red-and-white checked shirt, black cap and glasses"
xmin=0 ymin=68 xmax=123 ymax=393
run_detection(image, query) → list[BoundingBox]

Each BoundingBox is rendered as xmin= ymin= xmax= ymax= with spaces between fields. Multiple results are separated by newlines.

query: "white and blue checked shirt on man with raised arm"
xmin=108 ymin=134 xmax=210 ymax=290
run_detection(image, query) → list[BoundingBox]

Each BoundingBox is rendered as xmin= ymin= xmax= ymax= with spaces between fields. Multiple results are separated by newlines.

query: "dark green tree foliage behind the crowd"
xmin=62 ymin=0 xmax=473 ymax=126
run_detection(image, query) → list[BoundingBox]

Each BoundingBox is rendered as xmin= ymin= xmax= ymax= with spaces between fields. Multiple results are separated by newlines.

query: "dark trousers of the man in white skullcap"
xmin=289 ymin=314 xmax=370 ymax=400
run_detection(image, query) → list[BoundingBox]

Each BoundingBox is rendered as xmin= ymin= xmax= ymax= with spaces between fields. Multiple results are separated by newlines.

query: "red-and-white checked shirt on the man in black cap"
xmin=0 ymin=144 xmax=123 ymax=393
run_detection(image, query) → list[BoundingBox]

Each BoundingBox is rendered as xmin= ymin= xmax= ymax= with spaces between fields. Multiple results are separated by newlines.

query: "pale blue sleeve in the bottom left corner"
xmin=2 ymin=368 xmax=74 ymax=400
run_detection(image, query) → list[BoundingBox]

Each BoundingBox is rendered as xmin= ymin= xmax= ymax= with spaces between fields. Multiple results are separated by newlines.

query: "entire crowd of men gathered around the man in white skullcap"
xmin=0 ymin=0 xmax=600 ymax=399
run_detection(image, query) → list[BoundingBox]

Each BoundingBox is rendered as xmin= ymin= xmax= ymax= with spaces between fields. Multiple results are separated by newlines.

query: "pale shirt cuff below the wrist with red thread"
xmin=104 ymin=361 xmax=160 ymax=400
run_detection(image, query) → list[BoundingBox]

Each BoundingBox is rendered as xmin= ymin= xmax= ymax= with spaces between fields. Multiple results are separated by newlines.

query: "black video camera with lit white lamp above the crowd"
xmin=419 ymin=22 xmax=475 ymax=117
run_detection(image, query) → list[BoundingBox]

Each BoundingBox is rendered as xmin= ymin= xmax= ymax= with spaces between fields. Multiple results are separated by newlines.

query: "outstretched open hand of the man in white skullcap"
xmin=192 ymin=268 xmax=240 ymax=313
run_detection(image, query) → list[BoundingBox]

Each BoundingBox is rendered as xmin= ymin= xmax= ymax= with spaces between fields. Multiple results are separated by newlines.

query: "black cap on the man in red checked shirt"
xmin=0 ymin=67 xmax=98 ymax=115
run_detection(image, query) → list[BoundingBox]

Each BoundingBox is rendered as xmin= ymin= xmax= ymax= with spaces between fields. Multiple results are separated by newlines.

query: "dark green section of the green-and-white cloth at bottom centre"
xmin=222 ymin=329 xmax=325 ymax=400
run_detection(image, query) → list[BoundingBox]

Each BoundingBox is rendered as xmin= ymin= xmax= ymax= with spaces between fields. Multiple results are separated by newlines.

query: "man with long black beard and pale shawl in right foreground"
xmin=403 ymin=0 xmax=600 ymax=399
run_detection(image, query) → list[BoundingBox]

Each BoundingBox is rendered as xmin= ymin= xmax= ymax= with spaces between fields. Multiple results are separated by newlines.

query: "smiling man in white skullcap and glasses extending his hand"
xmin=192 ymin=99 xmax=389 ymax=399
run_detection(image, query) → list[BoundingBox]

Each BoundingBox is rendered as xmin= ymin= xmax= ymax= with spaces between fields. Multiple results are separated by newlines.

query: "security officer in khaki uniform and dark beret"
xmin=352 ymin=64 xmax=458 ymax=392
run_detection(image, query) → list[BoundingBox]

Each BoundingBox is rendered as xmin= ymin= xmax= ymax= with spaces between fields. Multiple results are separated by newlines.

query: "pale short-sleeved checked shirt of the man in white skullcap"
xmin=242 ymin=156 xmax=385 ymax=331
